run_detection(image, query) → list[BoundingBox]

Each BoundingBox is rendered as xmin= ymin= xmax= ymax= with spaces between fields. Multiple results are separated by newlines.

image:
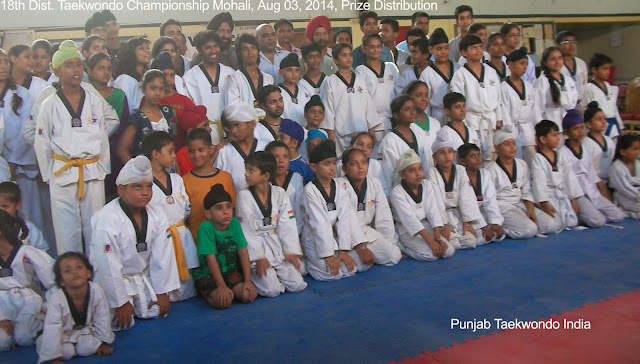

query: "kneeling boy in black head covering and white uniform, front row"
xmin=302 ymin=140 xmax=371 ymax=281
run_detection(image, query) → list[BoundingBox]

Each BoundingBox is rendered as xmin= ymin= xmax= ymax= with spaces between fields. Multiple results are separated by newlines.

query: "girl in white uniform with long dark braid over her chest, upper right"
xmin=533 ymin=47 xmax=578 ymax=132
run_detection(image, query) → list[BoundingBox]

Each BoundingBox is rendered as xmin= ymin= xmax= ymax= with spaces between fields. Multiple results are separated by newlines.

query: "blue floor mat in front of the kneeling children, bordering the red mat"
xmin=5 ymin=220 xmax=640 ymax=363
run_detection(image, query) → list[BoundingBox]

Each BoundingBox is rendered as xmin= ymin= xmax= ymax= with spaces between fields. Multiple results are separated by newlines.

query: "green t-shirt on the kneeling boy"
xmin=193 ymin=217 xmax=247 ymax=279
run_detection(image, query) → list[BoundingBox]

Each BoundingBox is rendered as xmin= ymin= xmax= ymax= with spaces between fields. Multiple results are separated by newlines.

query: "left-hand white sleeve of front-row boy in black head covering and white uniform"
xmin=304 ymin=188 xmax=336 ymax=258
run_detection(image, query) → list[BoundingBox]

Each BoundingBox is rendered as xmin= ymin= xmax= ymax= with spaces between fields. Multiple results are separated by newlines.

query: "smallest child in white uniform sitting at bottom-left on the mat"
xmin=36 ymin=252 xmax=116 ymax=363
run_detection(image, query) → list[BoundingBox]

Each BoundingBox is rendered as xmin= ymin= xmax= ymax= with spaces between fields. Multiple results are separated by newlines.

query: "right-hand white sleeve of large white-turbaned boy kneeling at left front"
xmin=149 ymin=209 xmax=180 ymax=294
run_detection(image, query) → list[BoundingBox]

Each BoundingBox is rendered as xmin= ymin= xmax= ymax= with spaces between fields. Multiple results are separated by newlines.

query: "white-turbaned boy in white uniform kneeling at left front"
xmin=90 ymin=156 xmax=180 ymax=330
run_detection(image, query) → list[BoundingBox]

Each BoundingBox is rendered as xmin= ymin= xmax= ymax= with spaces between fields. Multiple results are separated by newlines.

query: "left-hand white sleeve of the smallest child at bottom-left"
xmin=36 ymin=291 xmax=64 ymax=364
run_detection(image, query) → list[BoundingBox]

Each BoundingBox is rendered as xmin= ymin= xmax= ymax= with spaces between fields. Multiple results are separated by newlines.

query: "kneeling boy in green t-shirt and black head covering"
xmin=193 ymin=184 xmax=258 ymax=309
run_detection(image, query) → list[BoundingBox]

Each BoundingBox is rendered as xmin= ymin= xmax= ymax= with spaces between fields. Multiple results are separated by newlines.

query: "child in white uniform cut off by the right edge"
xmin=609 ymin=134 xmax=640 ymax=220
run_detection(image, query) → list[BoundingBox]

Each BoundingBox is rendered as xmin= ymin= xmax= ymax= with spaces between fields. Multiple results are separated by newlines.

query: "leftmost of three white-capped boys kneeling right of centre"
xmin=389 ymin=149 xmax=460 ymax=261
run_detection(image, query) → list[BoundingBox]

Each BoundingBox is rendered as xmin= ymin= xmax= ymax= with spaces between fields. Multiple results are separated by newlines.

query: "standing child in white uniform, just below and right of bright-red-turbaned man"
xmin=321 ymin=44 xmax=380 ymax=154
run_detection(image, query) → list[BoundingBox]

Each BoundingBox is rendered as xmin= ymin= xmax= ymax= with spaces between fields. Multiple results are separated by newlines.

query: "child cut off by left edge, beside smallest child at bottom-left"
xmin=0 ymin=211 xmax=54 ymax=351
